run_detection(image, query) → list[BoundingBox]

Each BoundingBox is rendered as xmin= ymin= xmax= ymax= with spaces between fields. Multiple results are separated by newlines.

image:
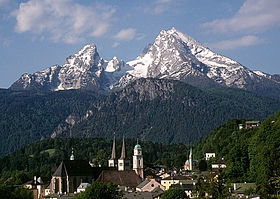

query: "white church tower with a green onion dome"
xmin=133 ymin=140 xmax=144 ymax=179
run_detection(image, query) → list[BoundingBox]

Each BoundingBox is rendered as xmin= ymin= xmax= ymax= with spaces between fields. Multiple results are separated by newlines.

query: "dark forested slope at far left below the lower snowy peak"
xmin=0 ymin=89 xmax=103 ymax=156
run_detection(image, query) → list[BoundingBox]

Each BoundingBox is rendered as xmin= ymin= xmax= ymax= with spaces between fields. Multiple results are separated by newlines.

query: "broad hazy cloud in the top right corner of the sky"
xmin=202 ymin=0 xmax=280 ymax=33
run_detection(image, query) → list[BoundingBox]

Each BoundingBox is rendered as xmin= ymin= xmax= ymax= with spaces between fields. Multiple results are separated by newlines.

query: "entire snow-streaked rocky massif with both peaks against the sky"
xmin=11 ymin=28 xmax=280 ymax=98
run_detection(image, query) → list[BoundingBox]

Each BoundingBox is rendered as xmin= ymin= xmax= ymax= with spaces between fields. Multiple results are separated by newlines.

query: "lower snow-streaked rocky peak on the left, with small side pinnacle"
xmin=10 ymin=44 xmax=129 ymax=91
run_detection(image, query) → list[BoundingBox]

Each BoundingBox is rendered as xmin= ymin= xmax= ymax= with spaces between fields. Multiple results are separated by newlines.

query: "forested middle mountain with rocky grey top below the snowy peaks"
xmin=51 ymin=78 xmax=280 ymax=143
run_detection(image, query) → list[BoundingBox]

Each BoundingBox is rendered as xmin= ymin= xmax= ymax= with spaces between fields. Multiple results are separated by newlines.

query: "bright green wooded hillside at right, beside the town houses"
xmin=195 ymin=112 xmax=280 ymax=194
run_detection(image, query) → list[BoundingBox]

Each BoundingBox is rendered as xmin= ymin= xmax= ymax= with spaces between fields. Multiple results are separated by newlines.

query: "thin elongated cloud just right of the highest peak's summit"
xmin=210 ymin=35 xmax=263 ymax=50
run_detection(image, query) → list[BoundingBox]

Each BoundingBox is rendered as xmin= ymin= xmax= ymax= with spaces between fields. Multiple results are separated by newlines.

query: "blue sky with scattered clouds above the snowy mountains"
xmin=0 ymin=0 xmax=280 ymax=88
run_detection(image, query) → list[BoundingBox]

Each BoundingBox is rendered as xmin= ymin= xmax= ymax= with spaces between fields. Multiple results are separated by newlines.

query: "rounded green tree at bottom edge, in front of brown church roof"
xmin=74 ymin=182 xmax=123 ymax=199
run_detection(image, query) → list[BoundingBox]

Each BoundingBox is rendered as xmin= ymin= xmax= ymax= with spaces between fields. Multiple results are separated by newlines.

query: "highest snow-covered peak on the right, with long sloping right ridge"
xmin=124 ymin=28 xmax=280 ymax=98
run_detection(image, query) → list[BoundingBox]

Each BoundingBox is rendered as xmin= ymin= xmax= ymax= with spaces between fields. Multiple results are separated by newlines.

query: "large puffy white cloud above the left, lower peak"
xmin=12 ymin=0 xmax=115 ymax=43
